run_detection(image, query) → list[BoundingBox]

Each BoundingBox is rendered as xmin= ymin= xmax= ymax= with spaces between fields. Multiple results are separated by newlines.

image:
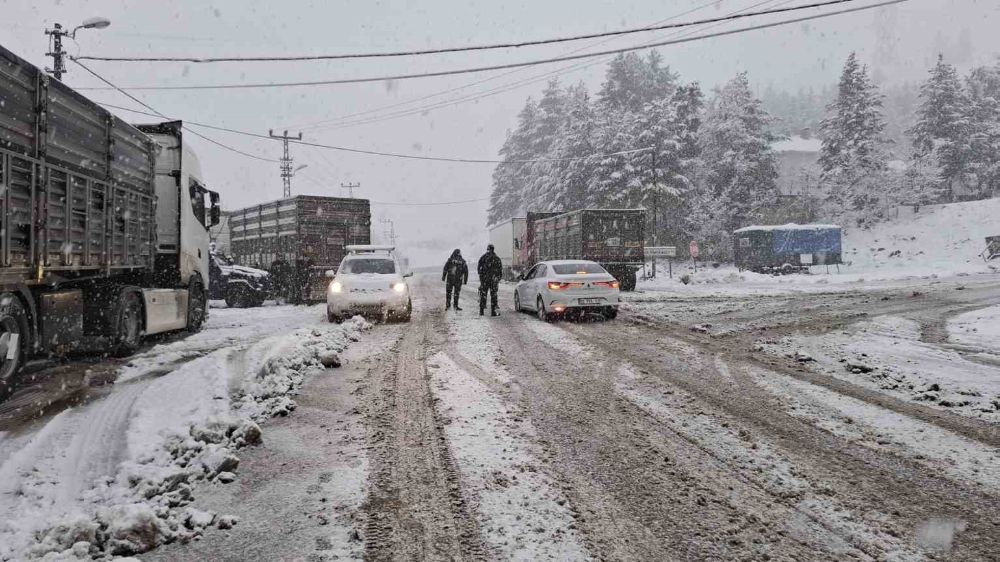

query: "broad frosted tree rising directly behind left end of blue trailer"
xmin=698 ymin=72 xmax=779 ymax=249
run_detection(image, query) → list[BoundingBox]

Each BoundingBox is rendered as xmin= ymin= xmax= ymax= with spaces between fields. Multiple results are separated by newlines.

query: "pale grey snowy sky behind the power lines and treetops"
xmin=0 ymin=0 xmax=1000 ymax=264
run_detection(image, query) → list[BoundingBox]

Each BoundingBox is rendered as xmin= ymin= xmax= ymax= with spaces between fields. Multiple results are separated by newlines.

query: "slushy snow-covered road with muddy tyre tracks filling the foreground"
xmin=0 ymin=277 xmax=1000 ymax=561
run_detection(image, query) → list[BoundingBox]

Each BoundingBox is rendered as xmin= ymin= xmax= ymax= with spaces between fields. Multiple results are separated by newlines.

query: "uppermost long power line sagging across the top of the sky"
xmin=77 ymin=0 xmax=856 ymax=63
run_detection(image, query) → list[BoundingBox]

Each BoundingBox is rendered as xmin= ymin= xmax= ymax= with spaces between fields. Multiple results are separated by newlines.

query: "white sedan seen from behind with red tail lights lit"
xmin=514 ymin=260 xmax=621 ymax=321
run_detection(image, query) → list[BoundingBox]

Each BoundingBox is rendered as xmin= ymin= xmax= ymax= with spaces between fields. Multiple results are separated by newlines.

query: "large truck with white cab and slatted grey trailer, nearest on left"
xmin=0 ymin=43 xmax=219 ymax=397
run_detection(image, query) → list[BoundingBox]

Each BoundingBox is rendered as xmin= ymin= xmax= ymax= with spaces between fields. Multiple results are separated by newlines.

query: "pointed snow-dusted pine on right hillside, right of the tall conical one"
xmin=907 ymin=55 xmax=972 ymax=201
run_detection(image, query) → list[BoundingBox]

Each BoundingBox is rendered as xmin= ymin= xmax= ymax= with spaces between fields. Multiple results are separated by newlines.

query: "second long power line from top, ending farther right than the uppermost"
xmin=73 ymin=0 xmax=909 ymax=90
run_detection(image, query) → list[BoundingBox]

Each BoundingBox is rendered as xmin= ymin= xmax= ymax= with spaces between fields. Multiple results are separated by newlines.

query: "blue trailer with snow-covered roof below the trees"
xmin=733 ymin=224 xmax=842 ymax=273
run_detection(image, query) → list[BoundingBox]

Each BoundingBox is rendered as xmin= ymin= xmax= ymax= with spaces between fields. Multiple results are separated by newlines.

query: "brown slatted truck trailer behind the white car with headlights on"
xmin=229 ymin=195 xmax=371 ymax=302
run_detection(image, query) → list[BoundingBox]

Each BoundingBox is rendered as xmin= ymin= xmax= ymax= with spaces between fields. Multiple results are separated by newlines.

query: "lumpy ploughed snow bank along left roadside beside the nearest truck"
xmin=0 ymin=310 xmax=367 ymax=560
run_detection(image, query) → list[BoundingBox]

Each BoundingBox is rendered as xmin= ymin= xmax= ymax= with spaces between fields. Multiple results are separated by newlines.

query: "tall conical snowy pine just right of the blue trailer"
xmin=819 ymin=53 xmax=887 ymax=217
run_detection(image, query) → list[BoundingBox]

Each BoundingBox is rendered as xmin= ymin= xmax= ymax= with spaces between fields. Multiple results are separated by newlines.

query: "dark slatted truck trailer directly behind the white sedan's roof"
xmin=527 ymin=209 xmax=646 ymax=291
